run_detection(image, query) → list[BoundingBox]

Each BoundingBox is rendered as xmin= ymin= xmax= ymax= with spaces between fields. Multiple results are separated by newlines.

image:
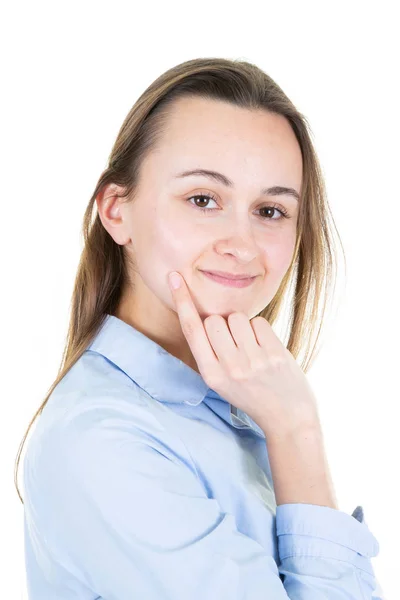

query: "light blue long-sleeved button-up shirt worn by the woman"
xmin=23 ymin=315 xmax=383 ymax=600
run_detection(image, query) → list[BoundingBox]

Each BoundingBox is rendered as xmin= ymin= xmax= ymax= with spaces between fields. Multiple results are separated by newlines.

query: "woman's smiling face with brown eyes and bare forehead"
xmin=99 ymin=98 xmax=302 ymax=336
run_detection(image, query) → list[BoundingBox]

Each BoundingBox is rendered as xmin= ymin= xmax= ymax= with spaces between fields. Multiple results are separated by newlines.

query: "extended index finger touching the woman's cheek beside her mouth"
xmin=168 ymin=271 xmax=218 ymax=379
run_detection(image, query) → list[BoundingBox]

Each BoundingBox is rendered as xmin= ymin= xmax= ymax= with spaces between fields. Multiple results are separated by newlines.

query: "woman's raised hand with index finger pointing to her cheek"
xmin=170 ymin=276 xmax=320 ymax=439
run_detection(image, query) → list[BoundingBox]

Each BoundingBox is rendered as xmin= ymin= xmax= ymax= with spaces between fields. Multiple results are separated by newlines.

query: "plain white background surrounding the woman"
xmin=0 ymin=0 xmax=400 ymax=600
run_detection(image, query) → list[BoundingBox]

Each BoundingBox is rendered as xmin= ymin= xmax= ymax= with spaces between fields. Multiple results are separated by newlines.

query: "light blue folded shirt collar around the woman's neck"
xmin=86 ymin=314 xmax=265 ymax=438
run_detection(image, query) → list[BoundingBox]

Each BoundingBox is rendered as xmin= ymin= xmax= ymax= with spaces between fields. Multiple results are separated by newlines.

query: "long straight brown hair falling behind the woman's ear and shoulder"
xmin=14 ymin=58 xmax=343 ymax=503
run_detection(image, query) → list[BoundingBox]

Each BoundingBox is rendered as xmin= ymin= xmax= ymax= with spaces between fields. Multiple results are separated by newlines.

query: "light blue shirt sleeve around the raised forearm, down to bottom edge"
xmin=276 ymin=504 xmax=384 ymax=600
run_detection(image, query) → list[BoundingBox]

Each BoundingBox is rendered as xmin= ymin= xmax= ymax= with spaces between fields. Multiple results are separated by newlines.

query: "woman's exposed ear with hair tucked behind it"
xmin=96 ymin=183 xmax=130 ymax=246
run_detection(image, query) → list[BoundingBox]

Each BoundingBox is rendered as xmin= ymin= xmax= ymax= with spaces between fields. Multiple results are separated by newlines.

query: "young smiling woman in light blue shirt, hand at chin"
xmin=17 ymin=58 xmax=379 ymax=600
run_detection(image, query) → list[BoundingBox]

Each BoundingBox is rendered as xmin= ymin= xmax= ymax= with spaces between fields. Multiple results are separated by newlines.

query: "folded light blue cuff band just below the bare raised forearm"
xmin=276 ymin=503 xmax=379 ymax=572
